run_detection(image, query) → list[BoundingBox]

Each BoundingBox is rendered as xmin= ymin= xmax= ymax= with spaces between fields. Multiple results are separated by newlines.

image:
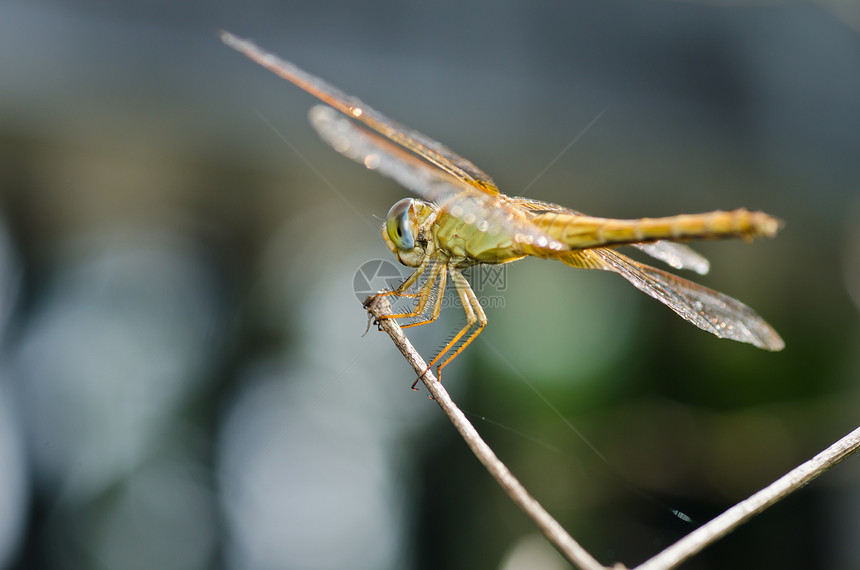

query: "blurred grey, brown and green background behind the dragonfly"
xmin=0 ymin=0 xmax=860 ymax=570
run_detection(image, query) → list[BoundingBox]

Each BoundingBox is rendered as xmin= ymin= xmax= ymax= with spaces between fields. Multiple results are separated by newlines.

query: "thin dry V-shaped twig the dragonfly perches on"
xmin=365 ymin=297 xmax=860 ymax=570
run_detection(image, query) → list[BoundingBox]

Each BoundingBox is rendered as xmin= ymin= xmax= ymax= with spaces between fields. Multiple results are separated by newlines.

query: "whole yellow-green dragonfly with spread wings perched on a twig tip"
xmin=220 ymin=31 xmax=785 ymax=377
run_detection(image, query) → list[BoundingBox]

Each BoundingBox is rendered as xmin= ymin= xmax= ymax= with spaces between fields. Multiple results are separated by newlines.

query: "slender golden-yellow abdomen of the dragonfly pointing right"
xmin=532 ymin=205 xmax=780 ymax=249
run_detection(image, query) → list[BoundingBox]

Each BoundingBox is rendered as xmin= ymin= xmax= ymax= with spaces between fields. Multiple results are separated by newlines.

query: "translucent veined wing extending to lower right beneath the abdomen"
xmin=560 ymin=248 xmax=785 ymax=350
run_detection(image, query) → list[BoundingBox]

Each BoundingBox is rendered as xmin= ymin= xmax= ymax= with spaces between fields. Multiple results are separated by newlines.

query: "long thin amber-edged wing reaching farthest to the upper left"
xmin=219 ymin=31 xmax=498 ymax=194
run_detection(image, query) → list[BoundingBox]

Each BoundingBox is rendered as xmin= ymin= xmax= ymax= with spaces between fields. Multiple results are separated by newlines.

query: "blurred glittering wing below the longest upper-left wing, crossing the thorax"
xmin=310 ymin=105 xmax=566 ymax=251
